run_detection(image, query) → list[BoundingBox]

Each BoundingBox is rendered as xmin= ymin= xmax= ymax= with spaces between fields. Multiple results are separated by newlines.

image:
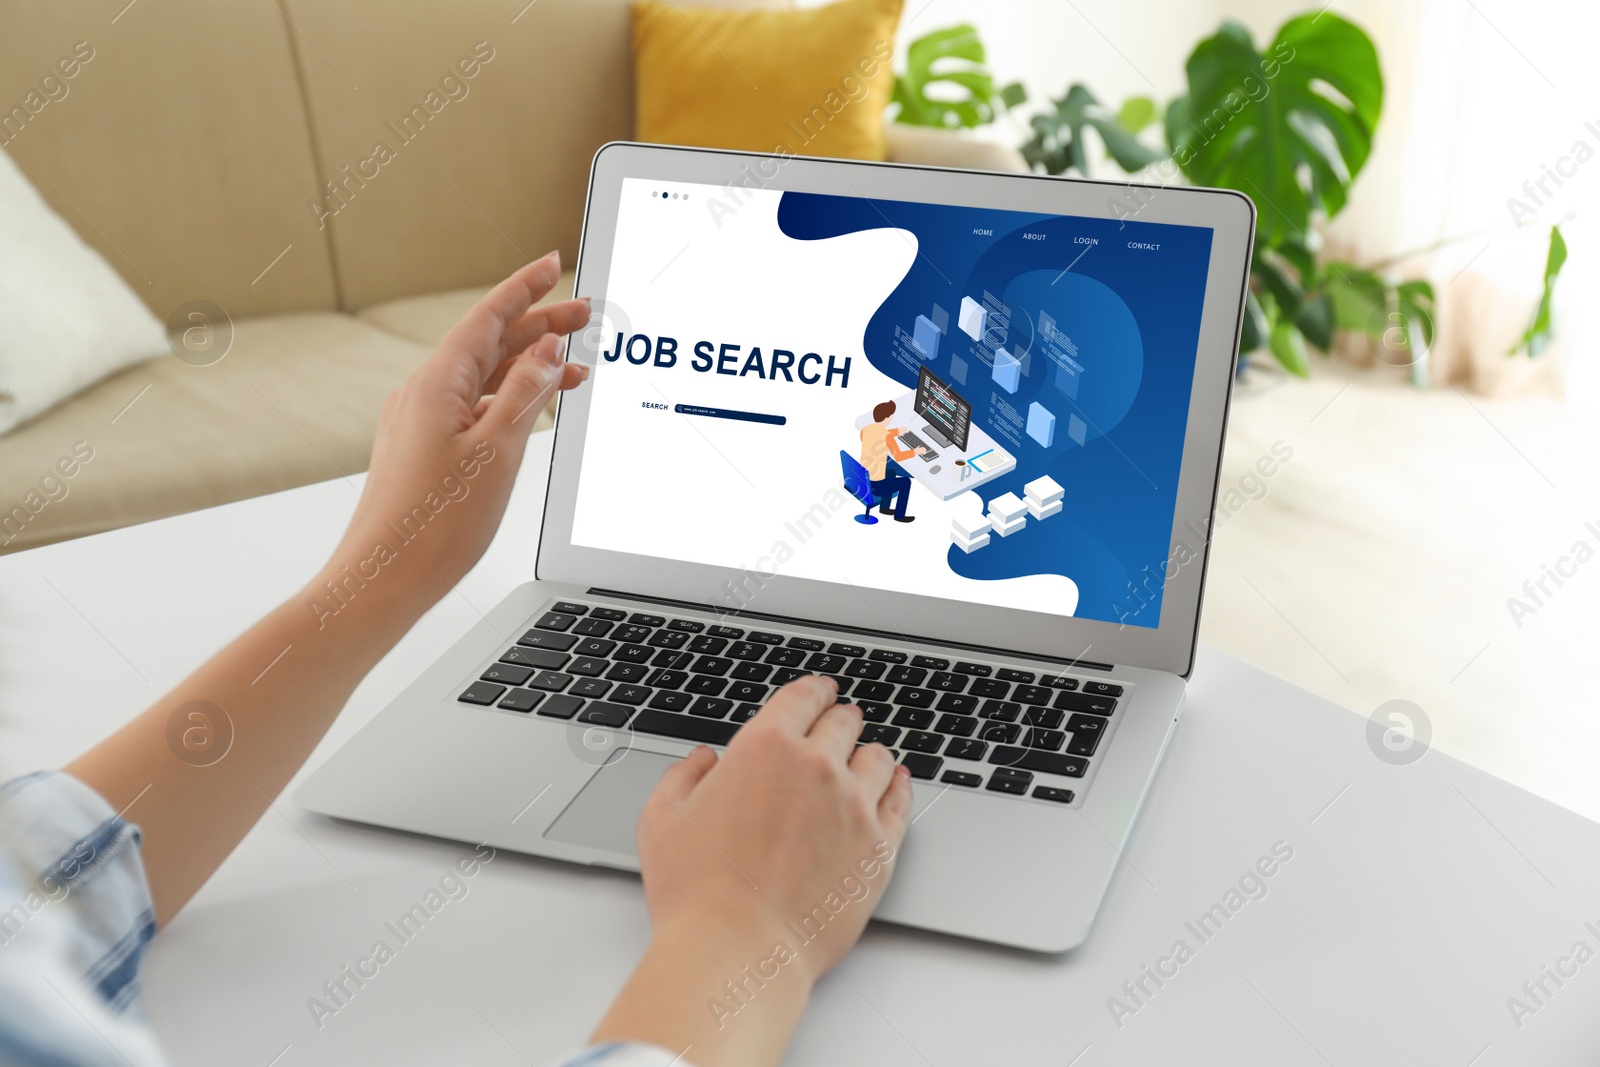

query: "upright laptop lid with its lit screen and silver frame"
xmin=536 ymin=142 xmax=1254 ymax=673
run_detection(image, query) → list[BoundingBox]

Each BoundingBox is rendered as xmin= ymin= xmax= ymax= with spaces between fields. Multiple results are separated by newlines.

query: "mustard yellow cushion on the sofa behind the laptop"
xmin=634 ymin=0 xmax=901 ymax=160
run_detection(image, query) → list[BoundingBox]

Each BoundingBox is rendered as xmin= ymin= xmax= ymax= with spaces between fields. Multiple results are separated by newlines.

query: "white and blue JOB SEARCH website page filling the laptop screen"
xmin=573 ymin=178 xmax=1211 ymax=627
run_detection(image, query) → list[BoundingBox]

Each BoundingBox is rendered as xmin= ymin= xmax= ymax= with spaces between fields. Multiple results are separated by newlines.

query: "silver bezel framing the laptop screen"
xmin=534 ymin=141 xmax=1256 ymax=675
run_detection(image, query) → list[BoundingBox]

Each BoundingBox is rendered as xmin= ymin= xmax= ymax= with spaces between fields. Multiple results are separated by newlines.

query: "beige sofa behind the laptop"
xmin=0 ymin=0 xmax=1024 ymax=550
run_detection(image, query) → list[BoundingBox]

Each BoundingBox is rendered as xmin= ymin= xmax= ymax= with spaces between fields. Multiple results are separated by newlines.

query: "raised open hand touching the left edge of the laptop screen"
xmin=326 ymin=251 xmax=589 ymax=608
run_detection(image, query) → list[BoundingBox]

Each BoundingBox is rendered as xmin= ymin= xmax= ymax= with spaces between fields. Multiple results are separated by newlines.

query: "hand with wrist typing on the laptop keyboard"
xmin=595 ymin=675 xmax=912 ymax=1067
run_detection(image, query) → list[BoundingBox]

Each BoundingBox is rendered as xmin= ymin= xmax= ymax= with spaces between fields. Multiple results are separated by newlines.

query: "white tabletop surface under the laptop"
xmin=0 ymin=434 xmax=1600 ymax=1067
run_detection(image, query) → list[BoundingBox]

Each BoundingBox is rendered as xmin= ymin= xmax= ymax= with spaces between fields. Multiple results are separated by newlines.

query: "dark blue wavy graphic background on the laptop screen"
xmin=778 ymin=192 xmax=1211 ymax=627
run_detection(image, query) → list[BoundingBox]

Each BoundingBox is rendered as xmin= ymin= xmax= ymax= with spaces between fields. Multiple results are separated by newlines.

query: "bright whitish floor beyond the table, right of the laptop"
xmin=1202 ymin=362 xmax=1600 ymax=819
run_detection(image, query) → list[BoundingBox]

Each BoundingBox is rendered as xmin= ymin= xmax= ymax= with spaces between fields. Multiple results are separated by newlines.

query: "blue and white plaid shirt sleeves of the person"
xmin=0 ymin=773 xmax=690 ymax=1067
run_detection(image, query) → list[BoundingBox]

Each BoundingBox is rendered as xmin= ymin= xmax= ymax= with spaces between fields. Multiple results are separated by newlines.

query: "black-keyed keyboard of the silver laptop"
xmin=458 ymin=600 xmax=1123 ymax=803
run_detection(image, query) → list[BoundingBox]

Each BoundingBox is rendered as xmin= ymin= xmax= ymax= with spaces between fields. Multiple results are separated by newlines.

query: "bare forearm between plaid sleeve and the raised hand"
xmin=66 ymin=549 xmax=424 ymax=925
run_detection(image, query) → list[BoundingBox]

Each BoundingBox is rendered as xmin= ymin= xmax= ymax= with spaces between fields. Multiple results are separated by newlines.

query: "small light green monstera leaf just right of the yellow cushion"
xmin=893 ymin=24 xmax=1027 ymax=130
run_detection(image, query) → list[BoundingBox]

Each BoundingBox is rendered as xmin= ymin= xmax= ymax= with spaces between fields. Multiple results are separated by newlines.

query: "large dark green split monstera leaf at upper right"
xmin=1166 ymin=10 xmax=1384 ymax=246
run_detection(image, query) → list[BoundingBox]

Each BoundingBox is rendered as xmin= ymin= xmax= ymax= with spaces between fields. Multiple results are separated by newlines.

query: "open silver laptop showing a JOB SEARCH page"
xmin=294 ymin=144 xmax=1254 ymax=952
